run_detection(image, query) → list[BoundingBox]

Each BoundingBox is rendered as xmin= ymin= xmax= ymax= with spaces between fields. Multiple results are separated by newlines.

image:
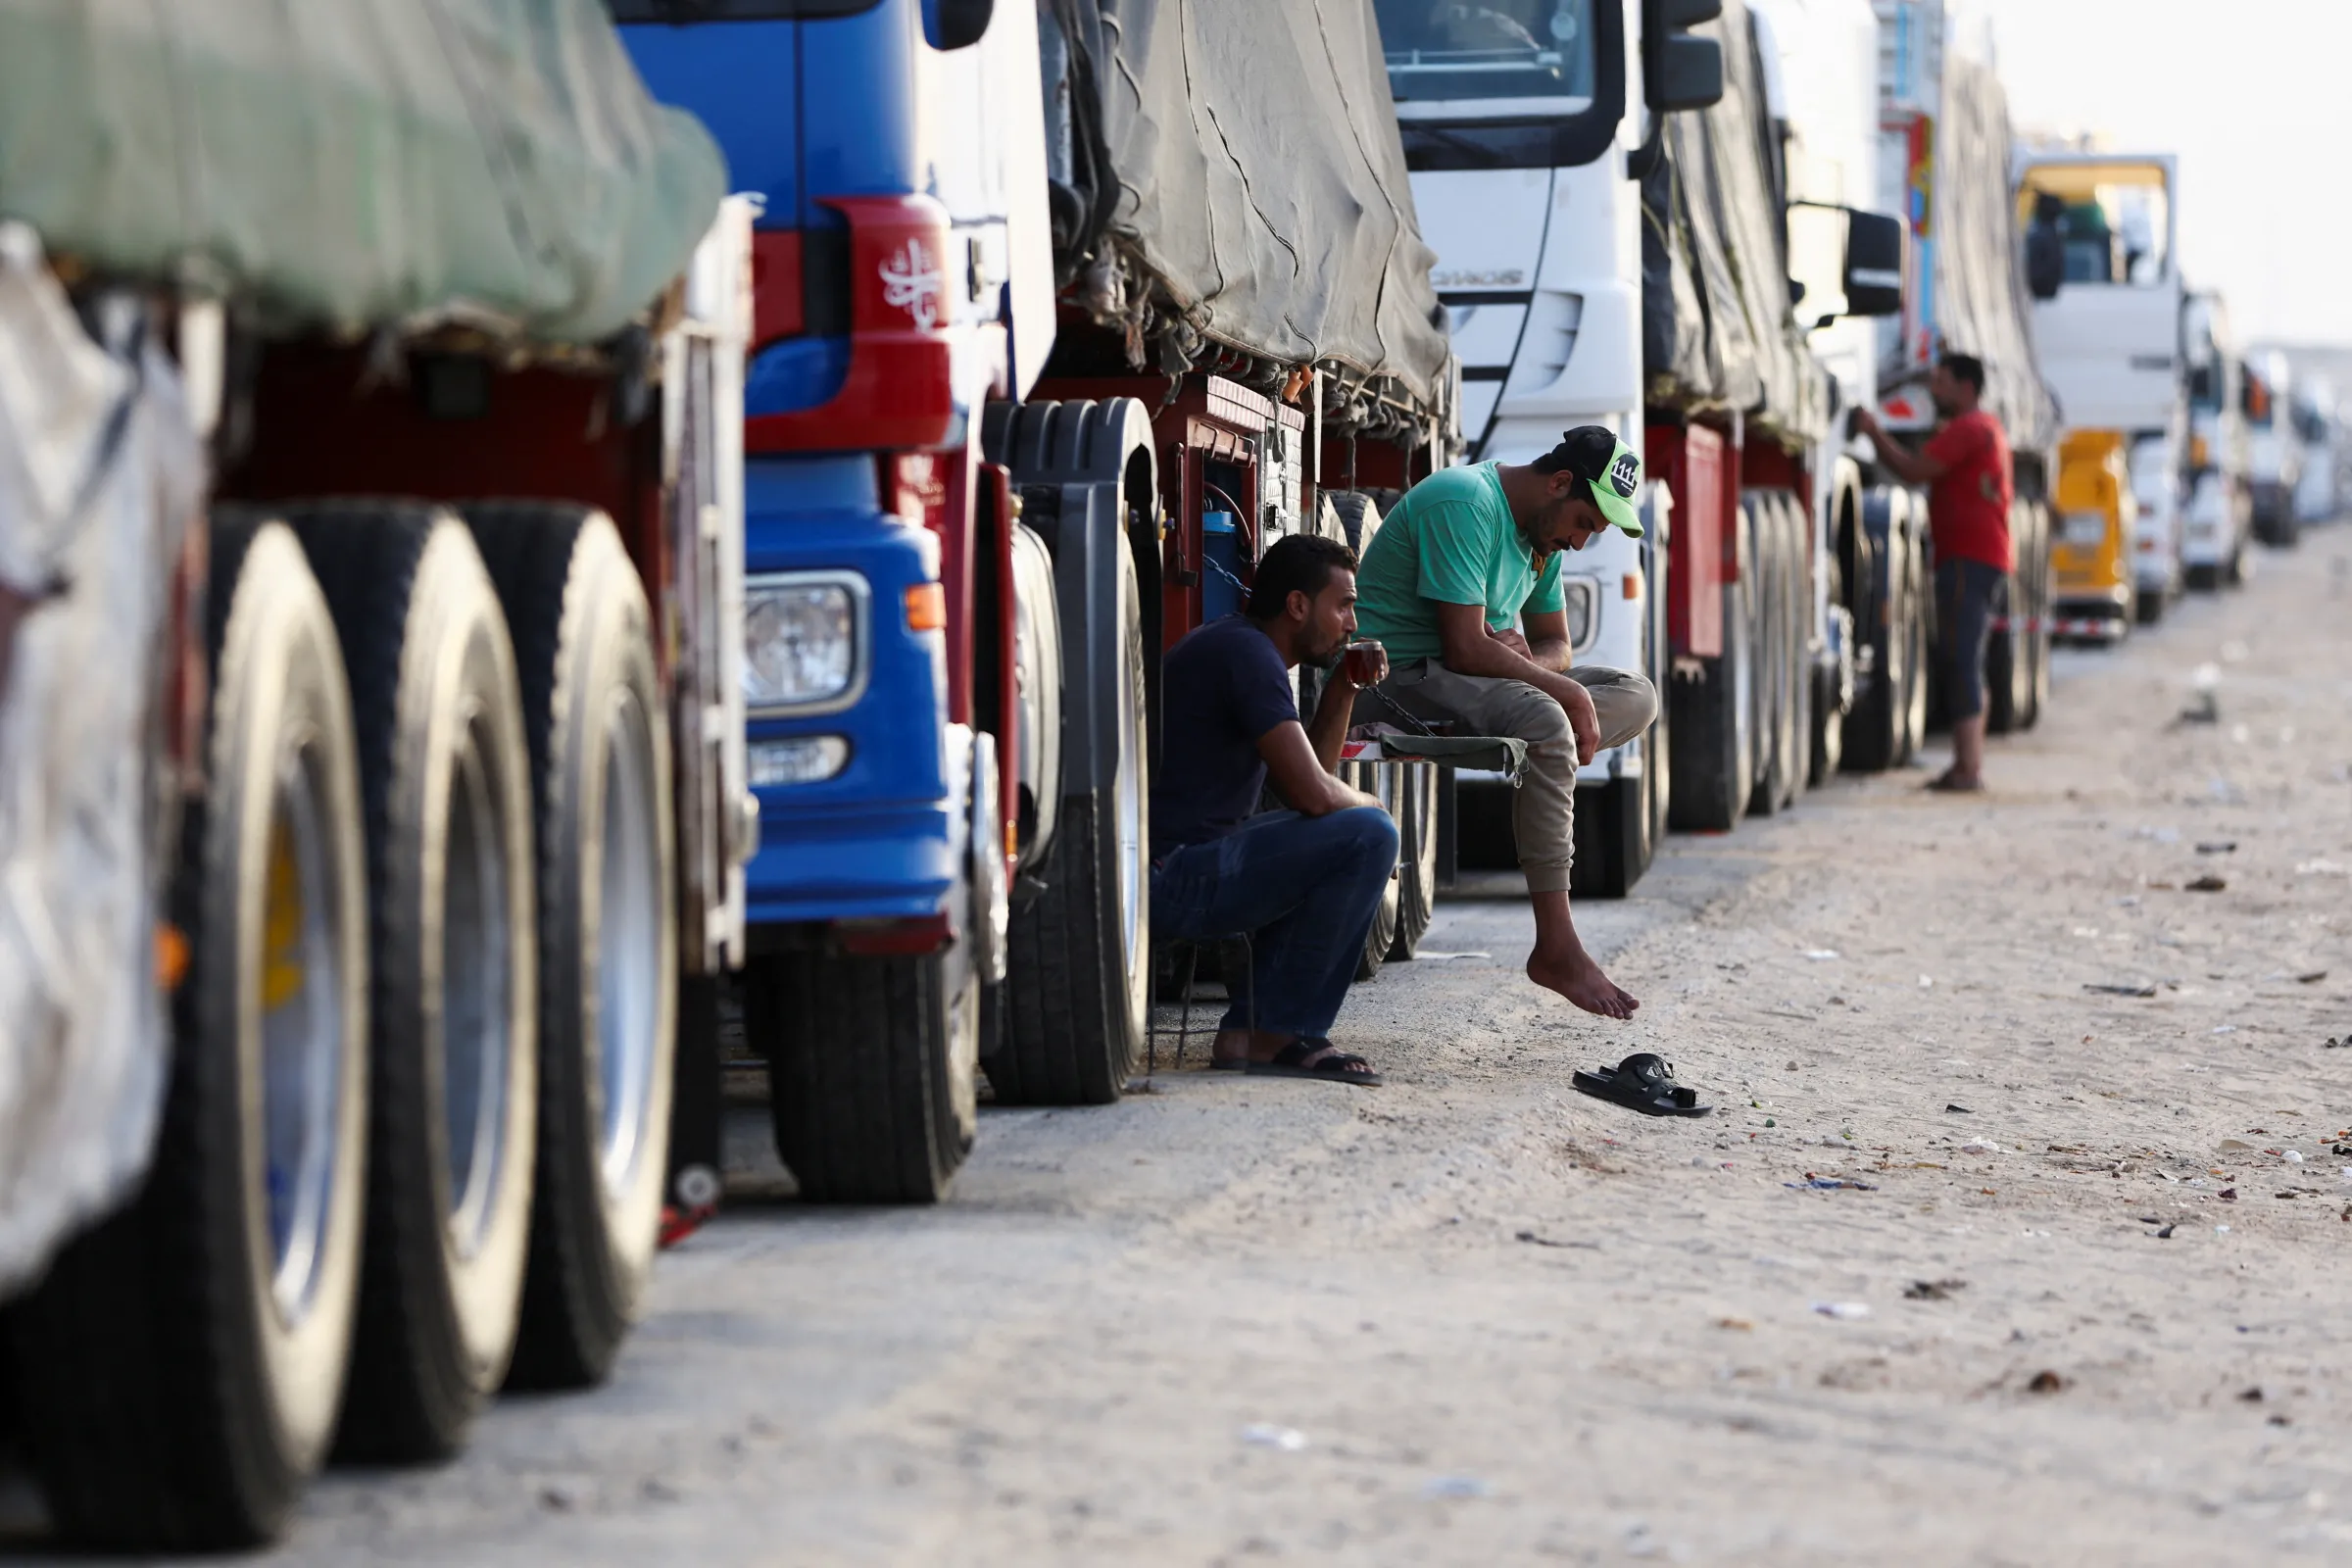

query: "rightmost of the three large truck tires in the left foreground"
xmin=466 ymin=503 xmax=677 ymax=1387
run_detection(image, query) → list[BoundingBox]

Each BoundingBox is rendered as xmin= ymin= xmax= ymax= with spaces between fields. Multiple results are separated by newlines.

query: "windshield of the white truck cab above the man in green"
xmin=1378 ymin=0 xmax=1594 ymax=113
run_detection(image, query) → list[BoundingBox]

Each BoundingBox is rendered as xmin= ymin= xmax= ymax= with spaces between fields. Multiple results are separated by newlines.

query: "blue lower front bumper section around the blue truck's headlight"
xmin=743 ymin=456 xmax=964 ymax=926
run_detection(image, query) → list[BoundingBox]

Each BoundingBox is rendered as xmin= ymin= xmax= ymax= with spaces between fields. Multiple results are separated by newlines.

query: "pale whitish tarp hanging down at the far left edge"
xmin=0 ymin=223 xmax=205 ymax=1300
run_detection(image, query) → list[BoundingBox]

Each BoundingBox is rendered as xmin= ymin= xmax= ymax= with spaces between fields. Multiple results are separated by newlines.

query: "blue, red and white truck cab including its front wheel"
xmin=610 ymin=0 xmax=1072 ymax=1201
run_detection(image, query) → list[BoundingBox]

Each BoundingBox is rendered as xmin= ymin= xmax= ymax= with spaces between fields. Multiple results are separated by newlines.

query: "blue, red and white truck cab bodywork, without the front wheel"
xmin=613 ymin=0 xmax=1052 ymax=930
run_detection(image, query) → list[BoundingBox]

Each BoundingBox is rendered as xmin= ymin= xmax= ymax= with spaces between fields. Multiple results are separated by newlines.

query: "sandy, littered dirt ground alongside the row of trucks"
xmin=14 ymin=529 xmax=2352 ymax=1563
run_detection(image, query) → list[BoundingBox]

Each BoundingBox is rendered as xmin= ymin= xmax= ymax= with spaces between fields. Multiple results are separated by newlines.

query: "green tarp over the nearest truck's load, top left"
xmin=0 ymin=0 xmax=727 ymax=343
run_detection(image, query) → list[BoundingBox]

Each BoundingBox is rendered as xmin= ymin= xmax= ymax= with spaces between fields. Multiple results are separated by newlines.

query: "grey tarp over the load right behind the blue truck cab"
xmin=1049 ymin=0 xmax=1448 ymax=420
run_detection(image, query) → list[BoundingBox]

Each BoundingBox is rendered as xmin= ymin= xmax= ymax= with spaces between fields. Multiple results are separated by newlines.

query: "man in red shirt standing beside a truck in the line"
xmin=1853 ymin=353 xmax=2016 ymax=790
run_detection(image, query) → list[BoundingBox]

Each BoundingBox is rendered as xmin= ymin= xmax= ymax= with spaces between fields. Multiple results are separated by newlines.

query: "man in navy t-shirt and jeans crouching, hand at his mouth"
xmin=1152 ymin=534 xmax=1397 ymax=1084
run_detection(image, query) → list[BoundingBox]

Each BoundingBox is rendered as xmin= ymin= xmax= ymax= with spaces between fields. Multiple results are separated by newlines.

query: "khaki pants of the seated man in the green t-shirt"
xmin=1354 ymin=659 xmax=1658 ymax=894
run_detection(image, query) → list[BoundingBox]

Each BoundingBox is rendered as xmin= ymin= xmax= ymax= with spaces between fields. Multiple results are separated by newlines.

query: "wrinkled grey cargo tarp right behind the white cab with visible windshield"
xmin=1642 ymin=0 xmax=1830 ymax=442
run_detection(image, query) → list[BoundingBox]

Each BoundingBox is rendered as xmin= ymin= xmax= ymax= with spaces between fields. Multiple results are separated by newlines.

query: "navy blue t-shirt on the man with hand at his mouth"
xmin=1152 ymin=615 xmax=1298 ymax=860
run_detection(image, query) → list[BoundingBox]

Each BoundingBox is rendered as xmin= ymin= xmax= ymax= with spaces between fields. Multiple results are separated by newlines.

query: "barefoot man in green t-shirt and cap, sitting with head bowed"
xmin=1354 ymin=425 xmax=1658 ymax=1018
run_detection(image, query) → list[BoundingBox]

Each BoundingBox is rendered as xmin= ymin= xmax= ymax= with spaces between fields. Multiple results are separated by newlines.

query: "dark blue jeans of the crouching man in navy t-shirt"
xmin=1152 ymin=807 xmax=1397 ymax=1039
